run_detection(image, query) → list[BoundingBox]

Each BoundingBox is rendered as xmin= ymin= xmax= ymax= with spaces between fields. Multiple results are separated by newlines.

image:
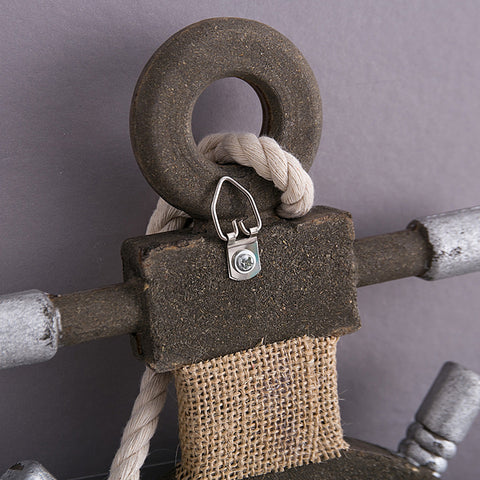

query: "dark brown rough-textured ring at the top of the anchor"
xmin=130 ymin=18 xmax=322 ymax=218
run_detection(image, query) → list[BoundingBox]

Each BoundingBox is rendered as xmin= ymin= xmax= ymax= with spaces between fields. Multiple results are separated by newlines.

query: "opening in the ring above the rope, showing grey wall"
xmin=192 ymin=78 xmax=263 ymax=143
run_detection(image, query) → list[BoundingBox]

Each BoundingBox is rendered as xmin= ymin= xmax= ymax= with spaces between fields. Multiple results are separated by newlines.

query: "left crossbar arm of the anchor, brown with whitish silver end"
xmin=0 ymin=281 xmax=143 ymax=369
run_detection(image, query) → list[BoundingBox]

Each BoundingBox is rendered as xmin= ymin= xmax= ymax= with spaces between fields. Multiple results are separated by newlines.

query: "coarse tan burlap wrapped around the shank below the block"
xmin=175 ymin=337 xmax=348 ymax=480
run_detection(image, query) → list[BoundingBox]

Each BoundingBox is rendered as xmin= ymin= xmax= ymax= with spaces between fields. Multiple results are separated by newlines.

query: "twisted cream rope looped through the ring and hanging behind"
xmin=108 ymin=133 xmax=314 ymax=480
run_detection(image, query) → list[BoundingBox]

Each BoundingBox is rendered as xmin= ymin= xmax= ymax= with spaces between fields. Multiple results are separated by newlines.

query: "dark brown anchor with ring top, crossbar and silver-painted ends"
xmin=0 ymin=18 xmax=480 ymax=480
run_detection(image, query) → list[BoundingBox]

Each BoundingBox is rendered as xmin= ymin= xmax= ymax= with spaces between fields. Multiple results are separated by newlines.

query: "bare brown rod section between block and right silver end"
xmin=354 ymin=230 xmax=432 ymax=287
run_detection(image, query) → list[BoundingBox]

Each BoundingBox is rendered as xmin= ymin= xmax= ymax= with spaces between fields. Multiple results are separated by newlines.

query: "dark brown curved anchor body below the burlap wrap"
xmin=162 ymin=438 xmax=435 ymax=480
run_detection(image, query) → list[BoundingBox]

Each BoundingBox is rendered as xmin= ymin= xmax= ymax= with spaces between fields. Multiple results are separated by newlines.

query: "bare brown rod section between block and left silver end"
xmin=50 ymin=281 xmax=143 ymax=345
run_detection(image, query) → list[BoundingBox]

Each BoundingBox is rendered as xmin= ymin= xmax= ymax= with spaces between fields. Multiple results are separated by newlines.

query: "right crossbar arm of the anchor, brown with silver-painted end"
xmin=354 ymin=206 xmax=480 ymax=287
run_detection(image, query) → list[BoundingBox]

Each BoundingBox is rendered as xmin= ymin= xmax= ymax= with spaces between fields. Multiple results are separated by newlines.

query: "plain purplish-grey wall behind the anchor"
xmin=0 ymin=0 xmax=480 ymax=480
